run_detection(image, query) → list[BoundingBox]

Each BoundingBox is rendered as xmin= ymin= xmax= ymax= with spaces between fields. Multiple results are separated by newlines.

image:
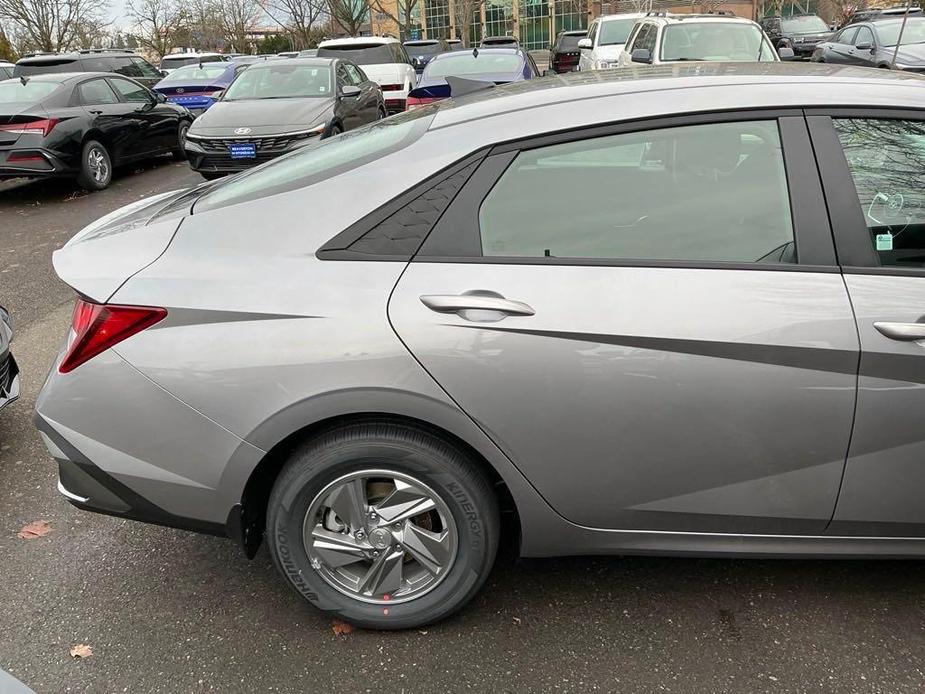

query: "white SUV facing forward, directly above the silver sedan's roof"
xmin=618 ymin=13 xmax=793 ymax=67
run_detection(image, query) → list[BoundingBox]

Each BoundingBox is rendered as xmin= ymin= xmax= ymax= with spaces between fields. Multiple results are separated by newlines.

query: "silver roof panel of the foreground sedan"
xmin=431 ymin=63 xmax=925 ymax=129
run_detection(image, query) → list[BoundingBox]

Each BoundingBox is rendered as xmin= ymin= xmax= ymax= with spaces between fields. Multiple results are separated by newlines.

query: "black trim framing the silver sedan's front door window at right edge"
xmin=805 ymin=107 xmax=925 ymax=277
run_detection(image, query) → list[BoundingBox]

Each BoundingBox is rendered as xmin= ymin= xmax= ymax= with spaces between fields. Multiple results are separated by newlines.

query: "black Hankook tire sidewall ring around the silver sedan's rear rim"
xmin=267 ymin=441 xmax=497 ymax=629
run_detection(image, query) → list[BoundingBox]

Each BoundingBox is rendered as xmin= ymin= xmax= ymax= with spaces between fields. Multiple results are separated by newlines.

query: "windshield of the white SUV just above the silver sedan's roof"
xmin=660 ymin=22 xmax=775 ymax=62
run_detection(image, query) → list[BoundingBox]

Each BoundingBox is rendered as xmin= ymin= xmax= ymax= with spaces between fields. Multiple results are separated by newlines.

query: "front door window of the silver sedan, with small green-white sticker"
xmin=832 ymin=118 xmax=925 ymax=268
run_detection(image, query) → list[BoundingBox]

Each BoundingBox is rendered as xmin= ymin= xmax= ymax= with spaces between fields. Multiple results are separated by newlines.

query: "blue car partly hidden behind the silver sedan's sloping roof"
xmin=406 ymin=48 xmax=540 ymax=111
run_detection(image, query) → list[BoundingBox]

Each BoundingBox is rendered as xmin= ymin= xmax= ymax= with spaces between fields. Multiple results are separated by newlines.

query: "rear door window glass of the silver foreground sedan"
xmin=479 ymin=121 xmax=796 ymax=263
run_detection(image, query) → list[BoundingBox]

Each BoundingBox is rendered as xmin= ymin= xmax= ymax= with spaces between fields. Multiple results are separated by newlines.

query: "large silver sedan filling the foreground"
xmin=36 ymin=63 xmax=925 ymax=628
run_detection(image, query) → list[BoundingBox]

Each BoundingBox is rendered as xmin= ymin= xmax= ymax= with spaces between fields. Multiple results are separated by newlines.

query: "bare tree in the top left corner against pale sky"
xmin=0 ymin=0 xmax=108 ymax=51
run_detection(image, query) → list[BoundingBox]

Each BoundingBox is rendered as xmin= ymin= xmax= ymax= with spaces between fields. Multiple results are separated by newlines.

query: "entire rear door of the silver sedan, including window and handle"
xmin=389 ymin=111 xmax=859 ymax=534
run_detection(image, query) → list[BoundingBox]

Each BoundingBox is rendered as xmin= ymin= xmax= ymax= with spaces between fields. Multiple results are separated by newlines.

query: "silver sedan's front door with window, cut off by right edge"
xmin=809 ymin=110 xmax=925 ymax=537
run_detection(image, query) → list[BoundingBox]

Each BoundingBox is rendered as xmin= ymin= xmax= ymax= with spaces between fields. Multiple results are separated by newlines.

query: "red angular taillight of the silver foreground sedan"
xmin=58 ymin=299 xmax=167 ymax=374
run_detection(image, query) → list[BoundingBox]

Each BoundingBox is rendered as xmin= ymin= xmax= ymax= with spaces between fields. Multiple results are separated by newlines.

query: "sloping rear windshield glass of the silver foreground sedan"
xmin=193 ymin=109 xmax=434 ymax=213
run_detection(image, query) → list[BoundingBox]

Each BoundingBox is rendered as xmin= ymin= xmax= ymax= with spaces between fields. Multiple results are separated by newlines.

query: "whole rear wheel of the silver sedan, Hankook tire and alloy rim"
xmin=266 ymin=421 xmax=499 ymax=629
